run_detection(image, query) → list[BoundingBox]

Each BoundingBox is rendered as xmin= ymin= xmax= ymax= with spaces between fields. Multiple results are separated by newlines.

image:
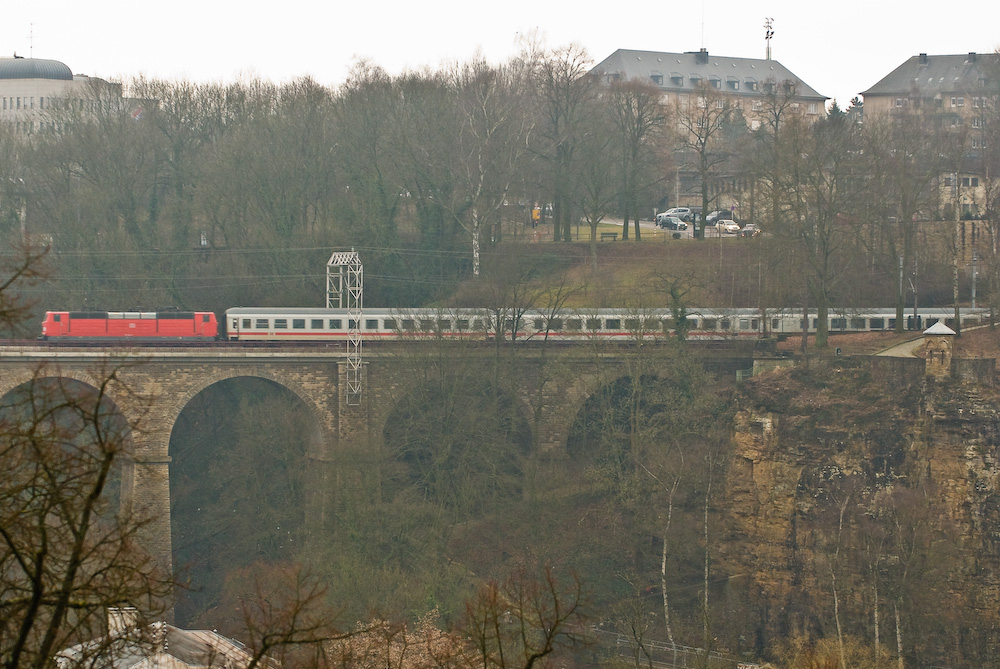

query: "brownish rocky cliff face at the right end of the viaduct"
xmin=724 ymin=358 xmax=1000 ymax=664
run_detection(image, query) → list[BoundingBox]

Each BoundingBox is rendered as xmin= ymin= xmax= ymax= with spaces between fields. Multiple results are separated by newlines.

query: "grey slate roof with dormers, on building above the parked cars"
xmin=591 ymin=49 xmax=827 ymax=101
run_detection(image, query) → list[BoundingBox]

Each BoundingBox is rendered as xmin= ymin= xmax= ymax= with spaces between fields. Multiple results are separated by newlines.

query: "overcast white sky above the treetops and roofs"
xmin=0 ymin=0 xmax=1000 ymax=107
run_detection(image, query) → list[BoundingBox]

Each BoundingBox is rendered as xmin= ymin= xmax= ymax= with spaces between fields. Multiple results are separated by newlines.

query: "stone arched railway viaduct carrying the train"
xmin=0 ymin=343 xmax=752 ymax=588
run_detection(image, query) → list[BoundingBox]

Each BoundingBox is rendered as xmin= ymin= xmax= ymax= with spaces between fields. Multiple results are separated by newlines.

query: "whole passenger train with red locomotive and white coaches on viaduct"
xmin=41 ymin=307 xmax=989 ymax=344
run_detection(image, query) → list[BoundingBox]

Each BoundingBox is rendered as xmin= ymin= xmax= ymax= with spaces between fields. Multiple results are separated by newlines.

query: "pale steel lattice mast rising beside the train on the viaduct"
xmin=326 ymin=249 xmax=365 ymax=405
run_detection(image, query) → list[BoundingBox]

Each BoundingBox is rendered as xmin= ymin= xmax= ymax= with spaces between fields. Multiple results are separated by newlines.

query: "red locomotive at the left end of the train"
xmin=42 ymin=310 xmax=219 ymax=342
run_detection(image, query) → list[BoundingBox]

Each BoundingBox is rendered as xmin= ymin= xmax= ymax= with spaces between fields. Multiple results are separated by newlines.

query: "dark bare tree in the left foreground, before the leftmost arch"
xmin=0 ymin=362 xmax=172 ymax=669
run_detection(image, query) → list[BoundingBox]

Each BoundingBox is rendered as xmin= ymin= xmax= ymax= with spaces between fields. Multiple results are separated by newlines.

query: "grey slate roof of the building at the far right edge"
xmin=862 ymin=53 xmax=997 ymax=97
